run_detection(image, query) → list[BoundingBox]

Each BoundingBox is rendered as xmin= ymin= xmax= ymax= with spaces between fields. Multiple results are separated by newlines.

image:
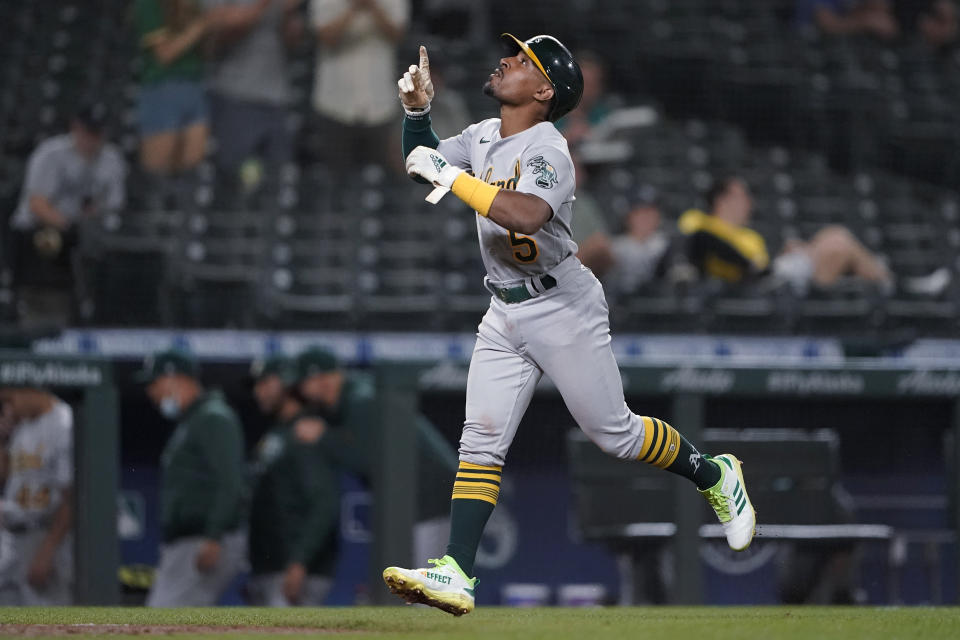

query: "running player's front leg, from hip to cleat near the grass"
xmin=383 ymin=301 xmax=541 ymax=616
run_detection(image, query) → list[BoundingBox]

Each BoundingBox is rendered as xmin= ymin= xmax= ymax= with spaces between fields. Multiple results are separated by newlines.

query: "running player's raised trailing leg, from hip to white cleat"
xmin=520 ymin=272 xmax=755 ymax=550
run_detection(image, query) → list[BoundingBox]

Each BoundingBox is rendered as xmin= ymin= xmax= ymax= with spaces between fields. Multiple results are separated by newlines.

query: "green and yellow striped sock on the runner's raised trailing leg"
xmin=637 ymin=416 xmax=721 ymax=491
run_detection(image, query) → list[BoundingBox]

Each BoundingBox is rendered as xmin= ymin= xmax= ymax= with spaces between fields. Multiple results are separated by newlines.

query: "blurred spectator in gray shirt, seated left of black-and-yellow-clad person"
xmin=605 ymin=186 xmax=670 ymax=294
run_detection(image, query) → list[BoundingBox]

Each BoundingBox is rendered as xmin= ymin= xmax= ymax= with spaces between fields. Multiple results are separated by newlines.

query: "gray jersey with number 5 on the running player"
xmin=437 ymin=118 xmax=577 ymax=283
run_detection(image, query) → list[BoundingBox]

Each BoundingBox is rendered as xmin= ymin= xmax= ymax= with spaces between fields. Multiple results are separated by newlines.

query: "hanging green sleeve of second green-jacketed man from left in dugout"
xmin=288 ymin=445 xmax=340 ymax=565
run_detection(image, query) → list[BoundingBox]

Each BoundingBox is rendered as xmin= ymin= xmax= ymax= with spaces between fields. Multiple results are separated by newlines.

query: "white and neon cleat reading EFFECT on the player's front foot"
xmin=383 ymin=556 xmax=477 ymax=616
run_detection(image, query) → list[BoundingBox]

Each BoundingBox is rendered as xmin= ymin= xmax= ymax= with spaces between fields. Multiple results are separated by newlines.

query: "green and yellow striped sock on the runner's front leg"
xmin=447 ymin=462 xmax=502 ymax=576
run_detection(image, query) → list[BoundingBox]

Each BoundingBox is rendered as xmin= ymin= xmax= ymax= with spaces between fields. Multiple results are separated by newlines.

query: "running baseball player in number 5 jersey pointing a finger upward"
xmin=383 ymin=34 xmax=756 ymax=615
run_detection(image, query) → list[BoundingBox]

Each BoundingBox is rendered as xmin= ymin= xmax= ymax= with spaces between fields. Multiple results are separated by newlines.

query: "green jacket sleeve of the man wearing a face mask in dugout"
xmin=199 ymin=416 xmax=244 ymax=539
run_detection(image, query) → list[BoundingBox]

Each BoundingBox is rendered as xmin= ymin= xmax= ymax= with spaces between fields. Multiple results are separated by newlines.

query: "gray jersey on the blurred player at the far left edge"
xmin=0 ymin=400 xmax=73 ymax=529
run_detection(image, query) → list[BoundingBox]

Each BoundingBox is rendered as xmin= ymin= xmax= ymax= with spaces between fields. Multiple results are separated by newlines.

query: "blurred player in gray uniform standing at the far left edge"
xmin=0 ymin=387 xmax=73 ymax=606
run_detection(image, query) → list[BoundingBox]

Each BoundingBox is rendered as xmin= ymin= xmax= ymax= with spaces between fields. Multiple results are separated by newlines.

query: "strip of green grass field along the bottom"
xmin=0 ymin=607 xmax=960 ymax=640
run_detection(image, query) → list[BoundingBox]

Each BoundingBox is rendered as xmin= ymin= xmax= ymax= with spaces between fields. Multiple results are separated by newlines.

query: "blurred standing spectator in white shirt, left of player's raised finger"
xmin=310 ymin=0 xmax=410 ymax=171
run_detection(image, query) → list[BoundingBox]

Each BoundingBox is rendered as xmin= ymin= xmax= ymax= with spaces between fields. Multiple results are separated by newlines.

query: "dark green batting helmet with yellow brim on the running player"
xmin=500 ymin=33 xmax=583 ymax=122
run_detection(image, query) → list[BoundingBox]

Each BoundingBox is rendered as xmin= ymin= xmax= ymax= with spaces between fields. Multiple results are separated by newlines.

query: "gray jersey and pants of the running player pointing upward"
xmin=437 ymin=118 xmax=644 ymax=465
